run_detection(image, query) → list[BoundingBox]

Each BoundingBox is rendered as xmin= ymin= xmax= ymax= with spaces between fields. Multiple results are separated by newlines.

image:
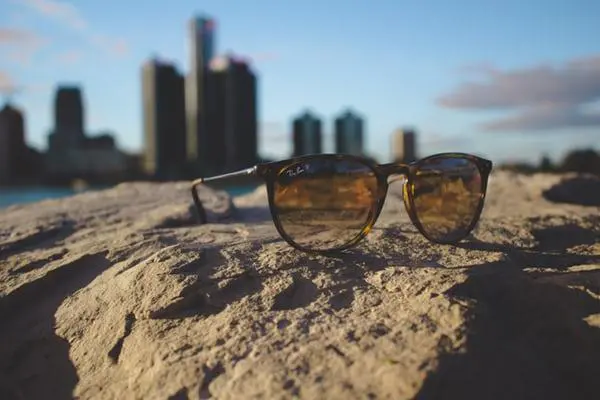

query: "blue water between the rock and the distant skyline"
xmin=0 ymin=186 xmax=256 ymax=208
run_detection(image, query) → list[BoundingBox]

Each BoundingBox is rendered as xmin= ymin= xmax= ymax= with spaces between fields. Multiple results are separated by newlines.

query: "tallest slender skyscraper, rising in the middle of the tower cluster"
xmin=185 ymin=17 xmax=216 ymax=169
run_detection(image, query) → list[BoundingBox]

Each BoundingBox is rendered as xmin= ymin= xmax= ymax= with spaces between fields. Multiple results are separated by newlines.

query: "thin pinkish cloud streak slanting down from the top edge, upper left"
xmin=13 ymin=0 xmax=128 ymax=57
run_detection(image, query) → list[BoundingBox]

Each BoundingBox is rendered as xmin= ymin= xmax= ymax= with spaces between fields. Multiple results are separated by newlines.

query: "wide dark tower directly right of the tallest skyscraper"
xmin=203 ymin=55 xmax=258 ymax=173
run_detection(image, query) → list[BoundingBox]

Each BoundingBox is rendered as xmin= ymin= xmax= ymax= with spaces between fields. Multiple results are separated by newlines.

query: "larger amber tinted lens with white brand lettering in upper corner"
xmin=273 ymin=159 xmax=377 ymax=251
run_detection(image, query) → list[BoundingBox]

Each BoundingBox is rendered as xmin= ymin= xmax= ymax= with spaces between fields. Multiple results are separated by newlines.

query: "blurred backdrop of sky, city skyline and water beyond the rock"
xmin=0 ymin=0 xmax=600 ymax=207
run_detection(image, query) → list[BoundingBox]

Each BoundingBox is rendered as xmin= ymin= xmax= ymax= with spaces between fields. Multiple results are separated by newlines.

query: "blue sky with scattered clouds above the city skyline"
xmin=0 ymin=0 xmax=600 ymax=162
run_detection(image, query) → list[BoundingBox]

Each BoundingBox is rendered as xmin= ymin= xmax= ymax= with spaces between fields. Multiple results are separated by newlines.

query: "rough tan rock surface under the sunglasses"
xmin=0 ymin=172 xmax=600 ymax=399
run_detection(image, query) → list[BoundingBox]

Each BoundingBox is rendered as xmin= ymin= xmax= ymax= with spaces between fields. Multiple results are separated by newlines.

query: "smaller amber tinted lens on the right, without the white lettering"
xmin=409 ymin=157 xmax=483 ymax=242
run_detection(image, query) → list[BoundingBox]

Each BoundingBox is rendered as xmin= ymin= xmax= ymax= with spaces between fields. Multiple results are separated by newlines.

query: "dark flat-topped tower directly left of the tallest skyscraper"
xmin=142 ymin=59 xmax=186 ymax=179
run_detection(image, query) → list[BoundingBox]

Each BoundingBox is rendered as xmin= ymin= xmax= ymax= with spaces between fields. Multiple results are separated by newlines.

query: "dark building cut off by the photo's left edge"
xmin=0 ymin=104 xmax=27 ymax=184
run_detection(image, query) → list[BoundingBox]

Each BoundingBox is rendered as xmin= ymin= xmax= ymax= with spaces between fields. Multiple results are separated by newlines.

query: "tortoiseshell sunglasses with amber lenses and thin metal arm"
xmin=192 ymin=153 xmax=492 ymax=253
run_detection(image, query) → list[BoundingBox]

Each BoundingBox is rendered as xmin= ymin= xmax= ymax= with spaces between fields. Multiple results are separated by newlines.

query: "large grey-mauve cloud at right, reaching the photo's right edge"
xmin=437 ymin=55 xmax=600 ymax=131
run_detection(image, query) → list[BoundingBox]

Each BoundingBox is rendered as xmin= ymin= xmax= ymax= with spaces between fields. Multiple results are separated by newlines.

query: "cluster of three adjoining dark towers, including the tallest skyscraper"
xmin=142 ymin=15 xmax=259 ymax=179
